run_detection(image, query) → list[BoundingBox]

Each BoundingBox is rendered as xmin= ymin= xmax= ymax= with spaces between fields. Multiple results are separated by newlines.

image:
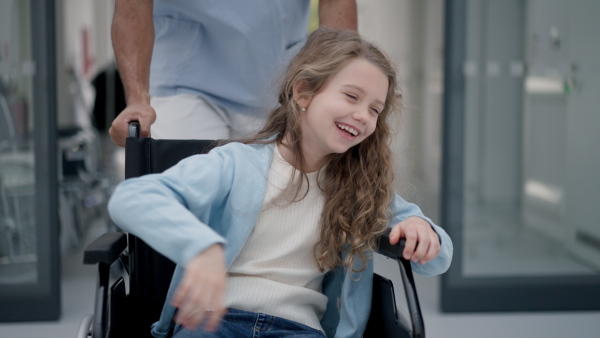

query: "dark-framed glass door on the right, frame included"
xmin=442 ymin=0 xmax=600 ymax=312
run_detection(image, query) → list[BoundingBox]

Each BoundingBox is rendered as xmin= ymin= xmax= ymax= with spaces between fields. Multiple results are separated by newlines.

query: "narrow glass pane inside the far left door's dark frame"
xmin=0 ymin=0 xmax=38 ymax=287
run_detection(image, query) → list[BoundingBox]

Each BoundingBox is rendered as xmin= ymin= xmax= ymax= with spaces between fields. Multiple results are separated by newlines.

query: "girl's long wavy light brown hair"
xmin=234 ymin=29 xmax=401 ymax=272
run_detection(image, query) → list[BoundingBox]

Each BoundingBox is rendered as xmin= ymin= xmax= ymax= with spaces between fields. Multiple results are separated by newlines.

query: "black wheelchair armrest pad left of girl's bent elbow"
xmin=83 ymin=232 xmax=127 ymax=265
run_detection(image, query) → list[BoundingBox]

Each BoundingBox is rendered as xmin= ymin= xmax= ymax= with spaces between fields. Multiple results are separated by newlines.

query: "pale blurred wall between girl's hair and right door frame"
xmin=357 ymin=0 xmax=444 ymax=218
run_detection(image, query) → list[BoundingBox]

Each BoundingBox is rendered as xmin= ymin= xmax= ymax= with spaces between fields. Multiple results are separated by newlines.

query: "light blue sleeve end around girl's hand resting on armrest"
xmin=390 ymin=194 xmax=454 ymax=276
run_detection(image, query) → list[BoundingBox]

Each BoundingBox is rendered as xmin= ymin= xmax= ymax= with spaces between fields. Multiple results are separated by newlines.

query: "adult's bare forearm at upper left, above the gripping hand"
xmin=111 ymin=0 xmax=154 ymax=105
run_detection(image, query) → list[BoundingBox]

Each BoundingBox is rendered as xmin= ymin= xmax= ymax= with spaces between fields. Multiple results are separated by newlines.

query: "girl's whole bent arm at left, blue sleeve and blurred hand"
xmin=108 ymin=149 xmax=234 ymax=331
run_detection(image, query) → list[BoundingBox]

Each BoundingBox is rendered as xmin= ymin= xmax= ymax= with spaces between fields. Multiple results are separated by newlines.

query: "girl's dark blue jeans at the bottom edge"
xmin=173 ymin=309 xmax=325 ymax=338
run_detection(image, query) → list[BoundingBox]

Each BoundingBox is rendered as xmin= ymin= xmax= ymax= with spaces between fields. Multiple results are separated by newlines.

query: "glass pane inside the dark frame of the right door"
xmin=462 ymin=0 xmax=600 ymax=277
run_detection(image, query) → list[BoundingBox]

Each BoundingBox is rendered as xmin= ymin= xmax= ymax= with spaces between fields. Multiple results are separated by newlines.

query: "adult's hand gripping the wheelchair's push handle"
xmin=108 ymin=103 xmax=156 ymax=147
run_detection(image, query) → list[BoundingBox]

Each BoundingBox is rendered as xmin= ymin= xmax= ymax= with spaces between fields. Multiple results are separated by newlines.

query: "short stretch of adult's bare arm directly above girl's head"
xmin=319 ymin=0 xmax=358 ymax=30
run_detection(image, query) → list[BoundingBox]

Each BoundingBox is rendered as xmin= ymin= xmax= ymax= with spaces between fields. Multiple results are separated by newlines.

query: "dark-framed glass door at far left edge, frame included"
xmin=0 ymin=0 xmax=60 ymax=321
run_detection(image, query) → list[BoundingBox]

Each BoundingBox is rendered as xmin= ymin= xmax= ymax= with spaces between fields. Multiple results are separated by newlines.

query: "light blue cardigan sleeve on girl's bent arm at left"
xmin=108 ymin=148 xmax=234 ymax=266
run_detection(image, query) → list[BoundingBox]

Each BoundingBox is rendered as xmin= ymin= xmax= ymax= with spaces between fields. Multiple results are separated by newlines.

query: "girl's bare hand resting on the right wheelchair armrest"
xmin=390 ymin=216 xmax=440 ymax=264
